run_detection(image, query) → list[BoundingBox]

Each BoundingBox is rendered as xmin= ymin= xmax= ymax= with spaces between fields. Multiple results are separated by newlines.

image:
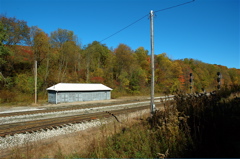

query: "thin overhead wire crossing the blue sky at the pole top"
xmin=100 ymin=0 xmax=195 ymax=43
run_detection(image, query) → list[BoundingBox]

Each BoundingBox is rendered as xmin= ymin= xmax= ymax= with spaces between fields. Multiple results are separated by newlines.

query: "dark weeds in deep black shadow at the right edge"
xmin=175 ymin=86 xmax=240 ymax=157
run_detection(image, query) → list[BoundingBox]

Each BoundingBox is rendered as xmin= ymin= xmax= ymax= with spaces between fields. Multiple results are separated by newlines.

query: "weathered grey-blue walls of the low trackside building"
xmin=48 ymin=91 xmax=111 ymax=103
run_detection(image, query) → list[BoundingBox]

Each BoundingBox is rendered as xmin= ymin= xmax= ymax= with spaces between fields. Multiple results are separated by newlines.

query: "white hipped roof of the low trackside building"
xmin=47 ymin=83 xmax=112 ymax=91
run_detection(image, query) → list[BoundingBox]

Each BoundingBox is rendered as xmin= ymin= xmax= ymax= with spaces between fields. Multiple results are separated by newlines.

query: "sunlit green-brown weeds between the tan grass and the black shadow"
xmin=81 ymin=99 xmax=192 ymax=158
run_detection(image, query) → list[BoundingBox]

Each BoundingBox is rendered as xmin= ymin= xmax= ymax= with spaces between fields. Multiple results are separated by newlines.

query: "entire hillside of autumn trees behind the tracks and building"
xmin=0 ymin=16 xmax=240 ymax=103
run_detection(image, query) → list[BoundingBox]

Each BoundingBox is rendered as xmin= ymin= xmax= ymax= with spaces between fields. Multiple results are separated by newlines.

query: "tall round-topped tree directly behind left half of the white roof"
xmin=50 ymin=29 xmax=80 ymax=82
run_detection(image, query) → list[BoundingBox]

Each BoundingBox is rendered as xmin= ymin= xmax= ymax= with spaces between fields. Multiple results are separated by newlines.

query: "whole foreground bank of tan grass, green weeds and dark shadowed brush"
xmin=2 ymin=87 xmax=240 ymax=158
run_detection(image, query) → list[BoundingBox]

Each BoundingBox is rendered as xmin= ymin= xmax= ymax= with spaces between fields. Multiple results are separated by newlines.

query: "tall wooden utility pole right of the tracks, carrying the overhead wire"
xmin=150 ymin=10 xmax=155 ymax=115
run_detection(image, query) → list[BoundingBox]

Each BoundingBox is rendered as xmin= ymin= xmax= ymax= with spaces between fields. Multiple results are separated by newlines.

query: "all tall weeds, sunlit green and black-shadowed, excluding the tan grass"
xmin=79 ymin=86 xmax=240 ymax=158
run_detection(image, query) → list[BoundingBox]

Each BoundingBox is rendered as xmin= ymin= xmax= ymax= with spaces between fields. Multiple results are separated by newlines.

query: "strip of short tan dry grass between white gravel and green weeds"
xmin=1 ymin=112 xmax=147 ymax=158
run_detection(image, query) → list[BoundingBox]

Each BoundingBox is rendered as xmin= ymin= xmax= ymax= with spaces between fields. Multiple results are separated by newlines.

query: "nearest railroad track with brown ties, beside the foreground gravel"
xmin=0 ymin=105 xmax=159 ymax=137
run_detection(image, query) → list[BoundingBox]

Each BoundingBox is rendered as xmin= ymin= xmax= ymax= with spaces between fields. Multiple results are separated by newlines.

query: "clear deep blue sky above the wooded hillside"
xmin=0 ymin=0 xmax=240 ymax=69
